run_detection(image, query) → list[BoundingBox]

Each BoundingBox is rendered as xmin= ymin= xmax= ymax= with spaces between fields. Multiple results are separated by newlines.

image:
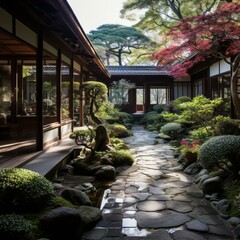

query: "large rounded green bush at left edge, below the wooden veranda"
xmin=0 ymin=168 xmax=53 ymax=212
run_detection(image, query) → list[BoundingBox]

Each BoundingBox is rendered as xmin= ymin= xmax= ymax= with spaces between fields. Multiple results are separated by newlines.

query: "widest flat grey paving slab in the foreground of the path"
xmin=135 ymin=211 xmax=191 ymax=228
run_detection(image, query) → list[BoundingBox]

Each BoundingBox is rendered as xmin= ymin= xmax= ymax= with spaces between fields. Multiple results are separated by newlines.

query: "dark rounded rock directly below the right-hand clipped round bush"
xmin=202 ymin=176 xmax=222 ymax=194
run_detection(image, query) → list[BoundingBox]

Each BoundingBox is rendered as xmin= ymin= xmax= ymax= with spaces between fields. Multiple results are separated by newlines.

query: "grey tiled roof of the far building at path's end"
xmin=106 ymin=66 xmax=168 ymax=76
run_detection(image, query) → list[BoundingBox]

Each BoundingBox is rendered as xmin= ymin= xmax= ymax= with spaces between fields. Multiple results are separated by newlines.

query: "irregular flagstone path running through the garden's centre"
xmin=82 ymin=126 xmax=234 ymax=240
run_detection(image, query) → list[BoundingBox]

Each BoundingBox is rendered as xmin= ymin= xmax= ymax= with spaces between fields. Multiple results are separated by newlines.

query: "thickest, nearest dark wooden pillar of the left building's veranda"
xmin=36 ymin=34 xmax=43 ymax=151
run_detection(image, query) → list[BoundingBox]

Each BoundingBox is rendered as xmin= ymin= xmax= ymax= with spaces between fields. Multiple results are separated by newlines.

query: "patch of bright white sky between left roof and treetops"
xmin=67 ymin=0 xmax=134 ymax=33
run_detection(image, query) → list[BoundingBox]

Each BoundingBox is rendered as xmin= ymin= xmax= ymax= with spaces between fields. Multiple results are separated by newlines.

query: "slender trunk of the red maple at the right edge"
xmin=231 ymin=54 xmax=240 ymax=118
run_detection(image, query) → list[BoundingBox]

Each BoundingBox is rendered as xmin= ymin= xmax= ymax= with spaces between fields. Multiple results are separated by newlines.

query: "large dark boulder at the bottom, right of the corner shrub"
xmin=40 ymin=207 xmax=81 ymax=239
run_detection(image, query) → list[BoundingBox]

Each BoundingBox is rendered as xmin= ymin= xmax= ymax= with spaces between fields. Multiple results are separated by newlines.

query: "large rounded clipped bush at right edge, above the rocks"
xmin=198 ymin=135 xmax=240 ymax=177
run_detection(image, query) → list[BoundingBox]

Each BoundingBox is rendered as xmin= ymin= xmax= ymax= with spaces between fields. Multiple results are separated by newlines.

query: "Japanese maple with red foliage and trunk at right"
xmin=152 ymin=2 xmax=240 ymax=116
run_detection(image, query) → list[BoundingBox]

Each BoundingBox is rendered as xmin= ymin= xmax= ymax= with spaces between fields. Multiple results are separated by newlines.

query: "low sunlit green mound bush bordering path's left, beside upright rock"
xmin=109 ymin=150 xmax=134 ymax=167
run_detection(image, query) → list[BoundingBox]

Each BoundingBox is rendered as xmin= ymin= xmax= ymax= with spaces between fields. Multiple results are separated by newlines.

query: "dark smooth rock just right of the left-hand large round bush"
xmin=61 ymin=188 xmax=92 ymax=206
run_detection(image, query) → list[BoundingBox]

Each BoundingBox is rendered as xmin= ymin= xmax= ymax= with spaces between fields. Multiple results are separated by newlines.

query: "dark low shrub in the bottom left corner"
xmin=0 ymin=214 xmax=33 ymax=240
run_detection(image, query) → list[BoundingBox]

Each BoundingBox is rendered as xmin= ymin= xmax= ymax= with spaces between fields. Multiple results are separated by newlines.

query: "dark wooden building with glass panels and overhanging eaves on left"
xmin=0 ymin=0 xmax=110 ymax=158
